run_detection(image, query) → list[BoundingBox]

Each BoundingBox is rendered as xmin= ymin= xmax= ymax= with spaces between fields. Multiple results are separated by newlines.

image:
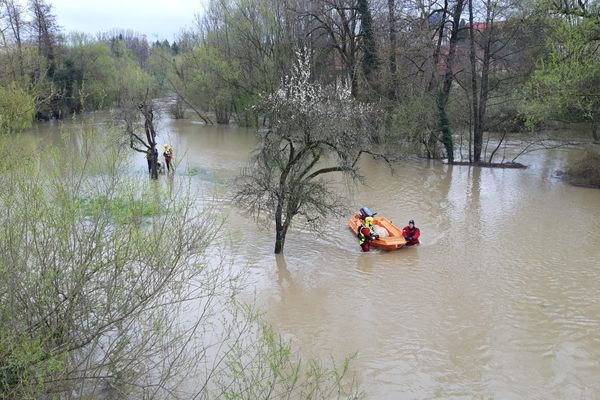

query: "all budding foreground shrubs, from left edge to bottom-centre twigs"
xmin=0 ymin=132 xmax=358 ymax=400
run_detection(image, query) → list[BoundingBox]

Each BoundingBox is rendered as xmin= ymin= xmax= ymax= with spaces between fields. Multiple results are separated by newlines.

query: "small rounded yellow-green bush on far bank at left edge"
xmin=0 ymin=83 xmax=35 ymax=134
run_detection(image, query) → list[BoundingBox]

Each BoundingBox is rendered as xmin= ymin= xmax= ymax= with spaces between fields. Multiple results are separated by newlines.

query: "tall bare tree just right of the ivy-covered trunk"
xmin=457 ymin=0 xmax=539 ymax=163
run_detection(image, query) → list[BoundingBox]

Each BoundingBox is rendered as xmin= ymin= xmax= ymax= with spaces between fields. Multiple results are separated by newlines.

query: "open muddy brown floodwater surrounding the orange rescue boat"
xmin=31 ymin=117 xmax=600 ymax=399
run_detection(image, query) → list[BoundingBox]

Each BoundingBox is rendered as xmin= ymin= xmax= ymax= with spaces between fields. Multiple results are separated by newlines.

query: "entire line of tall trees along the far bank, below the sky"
xmin=0 ymin=0 xmax=600 ymax=157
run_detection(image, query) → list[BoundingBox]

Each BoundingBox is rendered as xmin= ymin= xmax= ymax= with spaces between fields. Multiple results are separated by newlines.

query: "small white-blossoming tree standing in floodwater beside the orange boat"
xmin=236 ymin=53 xmax=387 ymax=253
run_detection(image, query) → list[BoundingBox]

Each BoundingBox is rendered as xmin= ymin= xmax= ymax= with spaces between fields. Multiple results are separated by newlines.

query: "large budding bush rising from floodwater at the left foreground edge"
xmin=0 ymin=130 xmax=223 ymax=399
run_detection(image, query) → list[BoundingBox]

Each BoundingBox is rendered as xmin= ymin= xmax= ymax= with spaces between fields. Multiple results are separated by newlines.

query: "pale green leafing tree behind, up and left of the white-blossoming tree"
xmin=185 ymin=0 xmax=297 ymax=126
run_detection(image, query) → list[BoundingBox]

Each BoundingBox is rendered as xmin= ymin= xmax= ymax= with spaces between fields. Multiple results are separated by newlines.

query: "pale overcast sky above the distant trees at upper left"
xmin=27 ymin=0 xmax=205 ymax=41
